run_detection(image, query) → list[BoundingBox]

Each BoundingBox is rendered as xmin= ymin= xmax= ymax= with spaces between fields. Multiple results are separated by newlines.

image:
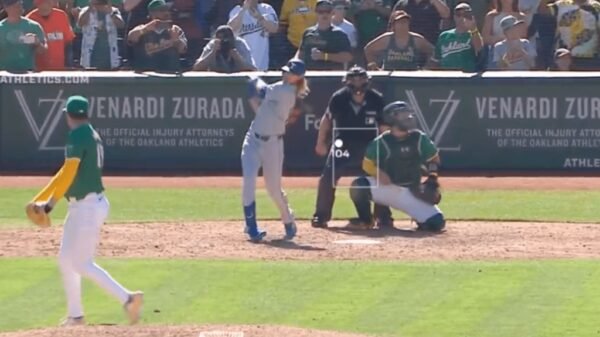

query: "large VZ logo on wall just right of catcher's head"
xmin=405 ymin=90 xmax=461 ymax=152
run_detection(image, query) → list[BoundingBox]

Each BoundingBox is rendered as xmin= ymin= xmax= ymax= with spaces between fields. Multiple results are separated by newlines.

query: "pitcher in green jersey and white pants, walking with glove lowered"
xmin=33 ymin=96 xmax=143 ymax=325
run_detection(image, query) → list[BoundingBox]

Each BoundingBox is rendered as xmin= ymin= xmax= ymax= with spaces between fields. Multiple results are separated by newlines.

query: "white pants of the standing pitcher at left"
xmin=58 ymin=193 xmax=129 ymax=317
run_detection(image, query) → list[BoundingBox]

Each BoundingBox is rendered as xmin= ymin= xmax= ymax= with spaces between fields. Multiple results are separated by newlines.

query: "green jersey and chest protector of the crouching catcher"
xmin=365 ymin=130 xmax=438 ymax=186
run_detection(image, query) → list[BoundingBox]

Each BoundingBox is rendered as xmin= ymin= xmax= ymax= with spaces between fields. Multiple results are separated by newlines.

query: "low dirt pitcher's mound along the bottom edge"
xmin=0 ymin=325 xmax=376 ymax=337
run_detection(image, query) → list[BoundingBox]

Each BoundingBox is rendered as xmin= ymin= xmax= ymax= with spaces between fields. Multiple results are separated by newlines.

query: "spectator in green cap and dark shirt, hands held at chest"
xmin=127 ymin=0 xmax=187 ymax=72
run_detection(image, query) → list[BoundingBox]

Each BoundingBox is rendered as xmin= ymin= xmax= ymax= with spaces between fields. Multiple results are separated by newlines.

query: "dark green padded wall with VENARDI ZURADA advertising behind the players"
xmin=0 ymin=72 xmax=600 ymax=174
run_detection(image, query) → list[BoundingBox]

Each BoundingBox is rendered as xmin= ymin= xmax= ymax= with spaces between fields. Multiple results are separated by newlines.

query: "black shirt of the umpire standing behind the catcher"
xmin=328 ymin=87 xmax=384 ymax=152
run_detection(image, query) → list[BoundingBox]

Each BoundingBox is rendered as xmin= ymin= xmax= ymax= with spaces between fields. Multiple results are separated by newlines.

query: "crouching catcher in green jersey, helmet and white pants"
xmin=348 ymin=101 xmax=446 ymax=232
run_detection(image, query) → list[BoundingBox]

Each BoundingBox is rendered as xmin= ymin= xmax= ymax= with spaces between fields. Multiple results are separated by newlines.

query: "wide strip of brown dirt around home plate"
xmin=0 ymin=222 xmax=600 ymax=261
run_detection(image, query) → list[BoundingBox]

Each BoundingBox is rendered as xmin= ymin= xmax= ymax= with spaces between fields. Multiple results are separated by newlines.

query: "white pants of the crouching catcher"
xmin=367 ymin=177 xmax=442 ymax=223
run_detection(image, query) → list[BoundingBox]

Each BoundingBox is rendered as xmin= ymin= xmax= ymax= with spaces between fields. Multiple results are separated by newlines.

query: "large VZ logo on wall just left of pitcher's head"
xmin=14 ymin=89 xmax=65 ymax=151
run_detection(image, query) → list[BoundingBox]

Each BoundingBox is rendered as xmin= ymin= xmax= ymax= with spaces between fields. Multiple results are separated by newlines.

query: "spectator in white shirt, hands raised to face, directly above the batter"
xmin=229 ymin=0 xmax=279 ymax=71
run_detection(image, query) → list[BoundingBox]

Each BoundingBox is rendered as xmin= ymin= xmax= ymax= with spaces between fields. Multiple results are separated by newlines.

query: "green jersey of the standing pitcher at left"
xmin=65 ymin=123 xmax=104 ymax=199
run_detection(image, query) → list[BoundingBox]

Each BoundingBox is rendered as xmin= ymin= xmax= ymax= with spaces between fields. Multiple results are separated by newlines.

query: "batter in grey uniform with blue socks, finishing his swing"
xmin=242 ymin=60 xmax=308 ymax=242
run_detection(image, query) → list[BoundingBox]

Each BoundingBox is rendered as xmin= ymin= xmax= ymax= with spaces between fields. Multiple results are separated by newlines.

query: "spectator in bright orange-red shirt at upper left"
xmin=27 ymin=0 xmax=75 ymax=71
